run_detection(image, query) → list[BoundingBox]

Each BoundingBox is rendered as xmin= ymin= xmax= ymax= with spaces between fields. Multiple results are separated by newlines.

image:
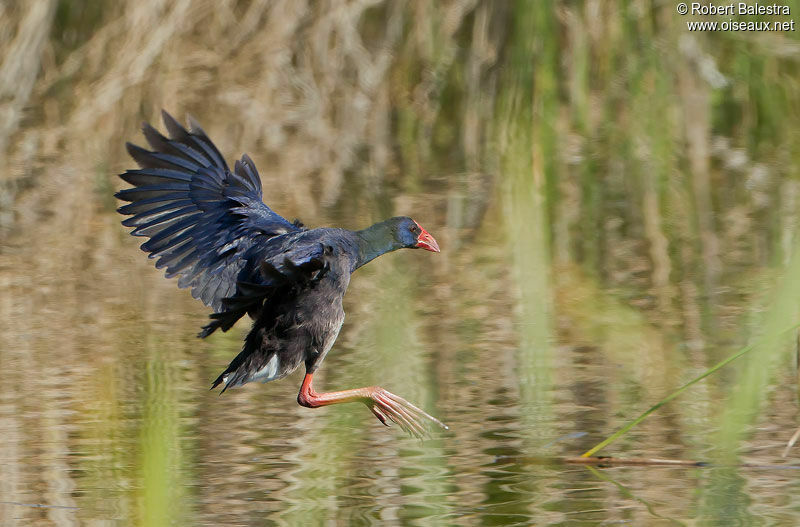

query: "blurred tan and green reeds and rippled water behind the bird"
xmin=0 ymin=0 xmax=800 ymax=525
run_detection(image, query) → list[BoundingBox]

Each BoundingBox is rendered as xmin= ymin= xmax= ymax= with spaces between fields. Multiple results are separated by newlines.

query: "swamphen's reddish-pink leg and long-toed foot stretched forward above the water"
xmin=297 ymin=373 xmax=447 ymax=437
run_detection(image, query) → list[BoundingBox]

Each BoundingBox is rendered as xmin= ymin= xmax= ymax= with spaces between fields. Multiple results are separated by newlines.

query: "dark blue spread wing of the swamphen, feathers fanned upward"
xmin=116 ymin=111 xmax=305 ymax=313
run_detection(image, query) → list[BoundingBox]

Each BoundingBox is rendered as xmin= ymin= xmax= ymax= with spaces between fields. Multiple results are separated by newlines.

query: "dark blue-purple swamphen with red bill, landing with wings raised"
xmin=116 ymin=112 xmax=446 ymax=436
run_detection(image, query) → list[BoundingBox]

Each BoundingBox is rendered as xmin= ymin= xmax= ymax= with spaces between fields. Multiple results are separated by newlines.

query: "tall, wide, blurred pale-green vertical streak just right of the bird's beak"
xmin=495 ymin=2 xmax=554 ymax=444
